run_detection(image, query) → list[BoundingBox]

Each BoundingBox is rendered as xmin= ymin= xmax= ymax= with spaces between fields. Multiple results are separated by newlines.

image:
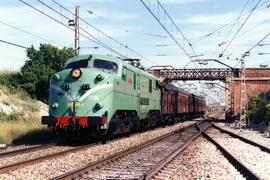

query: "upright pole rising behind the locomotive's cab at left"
xmin=68 ymin=6 xmax=80 ymax=56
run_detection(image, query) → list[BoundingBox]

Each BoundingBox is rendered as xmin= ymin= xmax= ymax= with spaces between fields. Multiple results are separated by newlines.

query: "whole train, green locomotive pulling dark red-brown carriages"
xmin=41 ymin=54 xmax=206 ymax=137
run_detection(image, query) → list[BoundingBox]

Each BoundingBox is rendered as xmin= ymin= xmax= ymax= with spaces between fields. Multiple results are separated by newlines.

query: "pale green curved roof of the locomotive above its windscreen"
xmin=65 ymin=54 xmax=158 ymax=80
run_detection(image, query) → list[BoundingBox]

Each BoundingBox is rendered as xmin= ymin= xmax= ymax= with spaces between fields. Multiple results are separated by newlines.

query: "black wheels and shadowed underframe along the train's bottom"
xmin=44 ymin=110 xmax=203 ymax=139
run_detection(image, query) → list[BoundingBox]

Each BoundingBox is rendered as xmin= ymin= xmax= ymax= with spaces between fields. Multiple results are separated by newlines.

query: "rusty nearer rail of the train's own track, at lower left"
xmin=0 ymin=144 xmax=96 ymax=173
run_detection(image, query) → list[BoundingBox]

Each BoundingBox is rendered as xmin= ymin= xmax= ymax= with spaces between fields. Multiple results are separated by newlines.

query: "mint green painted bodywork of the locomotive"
xmin=49 ymin=54 xmax=160 ymax=128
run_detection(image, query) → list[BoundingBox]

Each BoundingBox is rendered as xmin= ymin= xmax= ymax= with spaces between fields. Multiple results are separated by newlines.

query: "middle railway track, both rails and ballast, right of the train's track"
xmin=53 ymin=119 xmax=211 ymax=179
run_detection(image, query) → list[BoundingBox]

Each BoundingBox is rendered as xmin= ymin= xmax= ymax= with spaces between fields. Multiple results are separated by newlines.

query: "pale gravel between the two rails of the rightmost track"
xmin=207 ymin=129 xmax=270 ymax=179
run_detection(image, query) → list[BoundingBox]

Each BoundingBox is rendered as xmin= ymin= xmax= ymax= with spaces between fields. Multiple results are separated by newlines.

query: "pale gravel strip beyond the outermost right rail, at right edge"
xmin=215 ymin=123 xmax=270 ymax=147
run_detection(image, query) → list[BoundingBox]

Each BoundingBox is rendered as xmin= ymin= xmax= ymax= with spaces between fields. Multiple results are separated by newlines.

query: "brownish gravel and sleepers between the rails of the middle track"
xmin=78 ymin=127 xmax=197 ymax=179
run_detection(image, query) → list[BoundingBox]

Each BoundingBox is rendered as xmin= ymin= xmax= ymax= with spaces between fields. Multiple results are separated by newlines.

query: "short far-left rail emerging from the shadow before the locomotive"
xmin=0 ymin=143 xmax=56 ymax=158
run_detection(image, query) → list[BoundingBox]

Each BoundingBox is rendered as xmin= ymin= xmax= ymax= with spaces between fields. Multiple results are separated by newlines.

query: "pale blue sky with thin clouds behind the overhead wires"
xmin=0 ymin=0 xmax=270 ymax=70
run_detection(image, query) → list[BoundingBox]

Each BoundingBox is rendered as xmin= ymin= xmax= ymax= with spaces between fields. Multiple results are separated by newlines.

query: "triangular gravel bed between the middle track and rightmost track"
xmin=154 ymin=138 xmax=244 ymax=180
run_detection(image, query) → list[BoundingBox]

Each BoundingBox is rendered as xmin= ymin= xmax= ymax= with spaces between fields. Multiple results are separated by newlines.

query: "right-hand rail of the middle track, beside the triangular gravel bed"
xmin=140 ymin=121 xmax=213 ymax=180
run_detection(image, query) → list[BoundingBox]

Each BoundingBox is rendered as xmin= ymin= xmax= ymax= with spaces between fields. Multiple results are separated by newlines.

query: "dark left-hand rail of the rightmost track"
xmin=198 ymin=124 xmax=260 ymax=180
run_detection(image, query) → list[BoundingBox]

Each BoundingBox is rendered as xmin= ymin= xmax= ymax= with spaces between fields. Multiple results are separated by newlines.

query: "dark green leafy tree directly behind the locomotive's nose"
xmin=21 ymin=44 xmax=73 ymax=103
